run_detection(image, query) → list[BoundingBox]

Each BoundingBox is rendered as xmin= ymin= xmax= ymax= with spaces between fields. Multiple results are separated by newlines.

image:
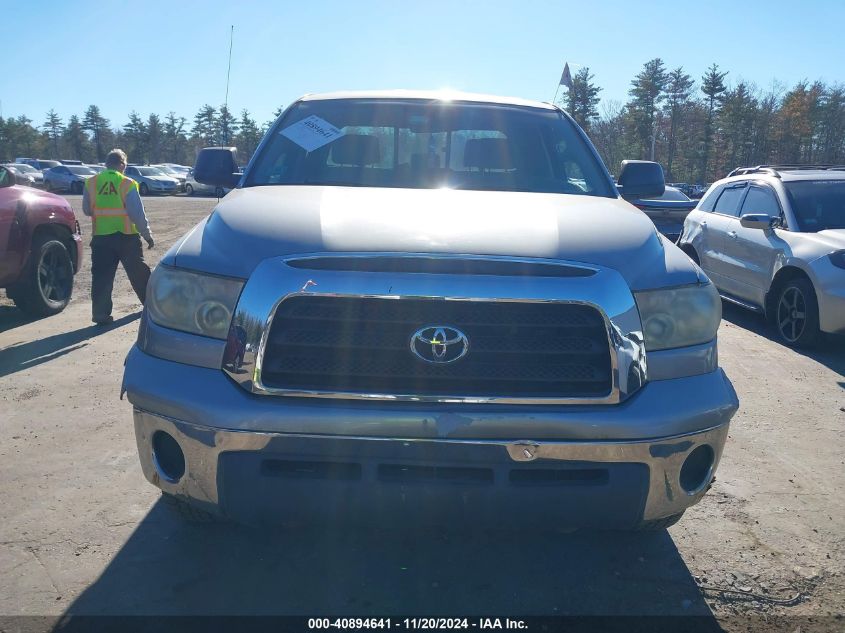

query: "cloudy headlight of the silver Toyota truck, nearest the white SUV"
xmin=634 ymin=283 xmax=722 ymax=351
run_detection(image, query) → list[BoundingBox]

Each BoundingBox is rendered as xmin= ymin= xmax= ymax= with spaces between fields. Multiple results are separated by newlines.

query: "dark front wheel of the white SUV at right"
xmin=771 ymin=277 xmax=819 ymax=347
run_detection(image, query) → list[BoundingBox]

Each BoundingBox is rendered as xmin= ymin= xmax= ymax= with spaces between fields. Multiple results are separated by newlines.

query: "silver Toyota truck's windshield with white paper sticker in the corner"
xmin=245 ymin=99 xmax=615 ymax=197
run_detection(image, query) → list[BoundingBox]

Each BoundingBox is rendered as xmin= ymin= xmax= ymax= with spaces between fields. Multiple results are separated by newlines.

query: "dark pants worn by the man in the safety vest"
xmin=91 ymin=233 xmax=150 ymax=321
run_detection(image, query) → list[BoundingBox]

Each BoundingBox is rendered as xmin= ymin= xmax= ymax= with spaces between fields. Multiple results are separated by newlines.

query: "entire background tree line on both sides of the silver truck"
xmin=0 ymin=58 xmax=845 ymax=183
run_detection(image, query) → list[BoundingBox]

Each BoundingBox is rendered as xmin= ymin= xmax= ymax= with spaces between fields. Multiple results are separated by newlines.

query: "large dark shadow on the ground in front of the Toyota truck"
xmin=56 ymin=501 xmax=721 ymax=631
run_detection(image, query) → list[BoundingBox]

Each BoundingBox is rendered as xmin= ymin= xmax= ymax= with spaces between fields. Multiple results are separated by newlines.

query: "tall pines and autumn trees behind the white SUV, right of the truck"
xmin=560 ymin=58 xmax=845 ymax=183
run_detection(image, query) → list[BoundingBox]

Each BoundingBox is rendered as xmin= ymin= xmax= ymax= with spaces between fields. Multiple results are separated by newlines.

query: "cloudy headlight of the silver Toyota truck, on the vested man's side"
xmin=146 ymin=265 xmax=244 ymax=339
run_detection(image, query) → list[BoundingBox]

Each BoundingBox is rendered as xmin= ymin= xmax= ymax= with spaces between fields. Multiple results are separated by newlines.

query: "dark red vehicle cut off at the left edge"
xmin=0 ymin=167 xmax=82 ymax=317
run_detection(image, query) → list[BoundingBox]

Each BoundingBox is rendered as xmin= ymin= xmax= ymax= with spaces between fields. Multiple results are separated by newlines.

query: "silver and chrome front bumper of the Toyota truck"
xmin=124 ymin=348 xmax=738 ymax=528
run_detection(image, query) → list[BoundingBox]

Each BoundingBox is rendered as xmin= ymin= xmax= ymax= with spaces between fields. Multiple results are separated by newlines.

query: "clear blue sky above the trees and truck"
xmin=0 ymin=0 xmax=845 ymax=126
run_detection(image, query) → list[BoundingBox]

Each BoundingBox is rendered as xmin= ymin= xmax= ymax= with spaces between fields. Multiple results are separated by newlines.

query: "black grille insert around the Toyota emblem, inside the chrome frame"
xmin=261 ymin=295 xmax=612 ymax=398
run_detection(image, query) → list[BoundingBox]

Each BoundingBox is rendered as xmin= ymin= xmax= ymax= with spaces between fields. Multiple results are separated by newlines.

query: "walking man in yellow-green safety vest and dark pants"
xmin=82 ymin=149 xmax=154 ymax=325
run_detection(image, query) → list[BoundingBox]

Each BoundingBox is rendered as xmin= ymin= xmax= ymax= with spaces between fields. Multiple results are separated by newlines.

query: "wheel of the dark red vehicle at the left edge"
xmin=13 ymin=236 xmax=73 ymax=317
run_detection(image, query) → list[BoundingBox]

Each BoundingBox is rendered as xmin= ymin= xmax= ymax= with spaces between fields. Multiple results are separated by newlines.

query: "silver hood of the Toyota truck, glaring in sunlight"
xmin=168 ymin=185 xmax=699 ymax=290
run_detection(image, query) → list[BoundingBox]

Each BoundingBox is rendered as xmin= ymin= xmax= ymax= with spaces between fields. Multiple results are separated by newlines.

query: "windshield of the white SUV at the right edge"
xmin=784 ymin=180 xmax=845 ymax=233
